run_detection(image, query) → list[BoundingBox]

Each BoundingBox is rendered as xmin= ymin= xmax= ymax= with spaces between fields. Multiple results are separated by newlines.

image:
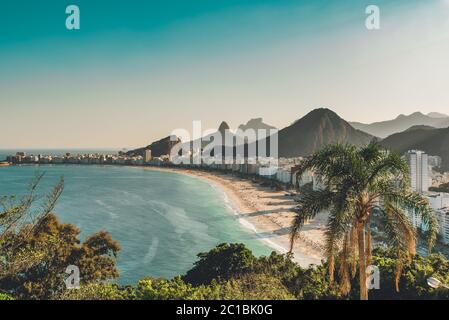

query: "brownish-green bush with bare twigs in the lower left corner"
xmin=0 ymin=175 xmax=120 ymax=299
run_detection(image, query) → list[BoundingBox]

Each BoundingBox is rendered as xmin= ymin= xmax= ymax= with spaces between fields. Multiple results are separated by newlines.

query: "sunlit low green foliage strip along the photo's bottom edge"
xmin=5 ymin=240 xmax=449 ymax=300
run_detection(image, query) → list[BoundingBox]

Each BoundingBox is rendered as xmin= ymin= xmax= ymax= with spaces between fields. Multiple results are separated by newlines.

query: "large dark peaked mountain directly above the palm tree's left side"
xmin=278 ymin=108 xmax=375 ymax=157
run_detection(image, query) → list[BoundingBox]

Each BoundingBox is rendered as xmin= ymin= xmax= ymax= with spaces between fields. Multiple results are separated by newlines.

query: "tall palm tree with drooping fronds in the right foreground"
xmin=291 ymin=142 xmax=438 ymax=300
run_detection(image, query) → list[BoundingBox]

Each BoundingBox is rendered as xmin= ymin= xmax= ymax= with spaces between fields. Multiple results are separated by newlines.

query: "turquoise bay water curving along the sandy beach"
xmin=0 ymin=165 xmax=272 ymax=284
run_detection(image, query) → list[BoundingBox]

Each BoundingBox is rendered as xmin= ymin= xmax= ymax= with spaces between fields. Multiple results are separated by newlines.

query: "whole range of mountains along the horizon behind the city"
xmin=128 ymin=108 xmax=449 ymax=170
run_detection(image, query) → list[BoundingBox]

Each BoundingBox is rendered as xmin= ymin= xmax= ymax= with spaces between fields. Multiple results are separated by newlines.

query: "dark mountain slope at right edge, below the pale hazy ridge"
xmin=380 ymin=128 xmax=449 ymax=170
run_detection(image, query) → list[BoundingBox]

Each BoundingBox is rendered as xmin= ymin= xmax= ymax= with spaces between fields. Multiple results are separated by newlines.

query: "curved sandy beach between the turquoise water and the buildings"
xmin=147 ymin=167 xmax=326 ymax=267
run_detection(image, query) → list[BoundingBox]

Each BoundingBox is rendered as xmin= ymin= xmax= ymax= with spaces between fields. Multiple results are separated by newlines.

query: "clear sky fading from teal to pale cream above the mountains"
xmin=0 ymin=0 xmax=449 ymax=149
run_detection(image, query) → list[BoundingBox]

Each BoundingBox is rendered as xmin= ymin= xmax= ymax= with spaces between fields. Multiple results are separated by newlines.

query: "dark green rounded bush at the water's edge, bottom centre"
xmin=183 ymin=243 xmax=255 ymax=285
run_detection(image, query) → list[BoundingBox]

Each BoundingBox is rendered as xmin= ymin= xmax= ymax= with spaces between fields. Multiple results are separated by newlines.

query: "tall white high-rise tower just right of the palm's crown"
xmin=407 ymin=150 xmax=429 ymax=193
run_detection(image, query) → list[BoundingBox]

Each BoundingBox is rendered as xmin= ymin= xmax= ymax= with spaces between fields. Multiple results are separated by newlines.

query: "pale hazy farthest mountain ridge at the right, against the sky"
xmin=350 ymin=112 xmax=449 ymax=138
